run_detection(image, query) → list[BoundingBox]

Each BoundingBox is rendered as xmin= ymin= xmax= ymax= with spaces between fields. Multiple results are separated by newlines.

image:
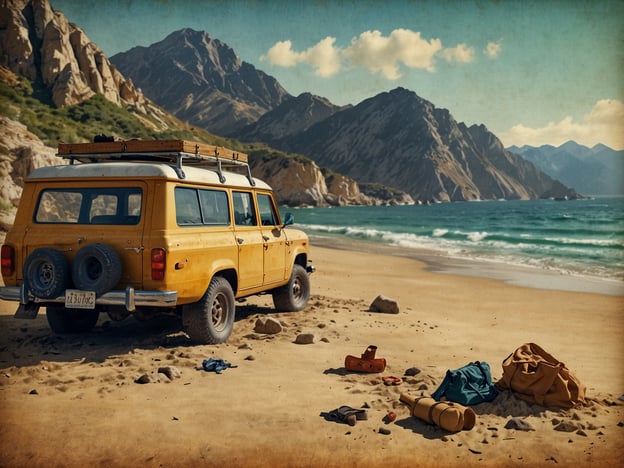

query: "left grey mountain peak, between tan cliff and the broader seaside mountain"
xmin=111 ymin=29 xmax=290 ymax=136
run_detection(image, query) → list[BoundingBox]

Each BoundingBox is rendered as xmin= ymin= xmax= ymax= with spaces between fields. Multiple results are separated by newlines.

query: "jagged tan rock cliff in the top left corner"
xmin=0 ymin=0 xmax=147 ymax=113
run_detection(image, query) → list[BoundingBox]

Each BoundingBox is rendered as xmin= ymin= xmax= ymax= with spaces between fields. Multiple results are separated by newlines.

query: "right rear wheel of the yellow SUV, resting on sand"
xmin=182 ymin=276 xmax=236 ymax=344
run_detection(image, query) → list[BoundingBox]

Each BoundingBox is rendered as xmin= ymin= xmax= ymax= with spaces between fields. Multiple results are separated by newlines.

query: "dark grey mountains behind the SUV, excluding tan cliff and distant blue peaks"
xmin=111 ymin=29 xmax=578 ymax=201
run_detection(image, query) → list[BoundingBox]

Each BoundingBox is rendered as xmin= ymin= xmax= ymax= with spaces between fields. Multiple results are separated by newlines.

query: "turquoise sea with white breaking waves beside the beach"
xmin=288 ymin=198 xmax=624 ymax=280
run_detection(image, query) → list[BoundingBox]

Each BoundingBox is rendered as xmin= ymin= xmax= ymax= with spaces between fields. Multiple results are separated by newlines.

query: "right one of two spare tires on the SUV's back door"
xmin=72 ymin=244 xmax=121 ymax=295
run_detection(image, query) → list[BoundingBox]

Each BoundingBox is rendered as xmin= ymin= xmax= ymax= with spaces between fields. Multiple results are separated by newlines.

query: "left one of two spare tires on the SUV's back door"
xmin=24 ymin=248 xmax=69 ymax=299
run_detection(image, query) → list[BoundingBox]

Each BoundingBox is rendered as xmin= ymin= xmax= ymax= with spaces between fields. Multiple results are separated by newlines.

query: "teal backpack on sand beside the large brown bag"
xmin=431 ymin=361 xmax=498 ymax=405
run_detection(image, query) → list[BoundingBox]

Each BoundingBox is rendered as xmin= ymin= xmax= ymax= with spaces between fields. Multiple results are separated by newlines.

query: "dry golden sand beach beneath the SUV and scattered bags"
xmin=0 ymin=239 xmax=624 ymax=467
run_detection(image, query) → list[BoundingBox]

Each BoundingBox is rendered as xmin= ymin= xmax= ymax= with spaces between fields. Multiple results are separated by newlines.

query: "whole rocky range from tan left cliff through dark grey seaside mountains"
xmin=0 ymin=0 xmax=600 ymax=208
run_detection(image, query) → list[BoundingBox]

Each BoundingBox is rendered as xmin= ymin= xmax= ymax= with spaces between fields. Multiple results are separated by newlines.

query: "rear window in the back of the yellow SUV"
xmin=35 ymin=187 xmax=143 ymax=225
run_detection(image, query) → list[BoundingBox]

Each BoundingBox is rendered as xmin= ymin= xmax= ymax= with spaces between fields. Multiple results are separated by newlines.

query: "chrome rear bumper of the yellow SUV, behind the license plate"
xmin=0 ymin=286 xmax=178 ymax=312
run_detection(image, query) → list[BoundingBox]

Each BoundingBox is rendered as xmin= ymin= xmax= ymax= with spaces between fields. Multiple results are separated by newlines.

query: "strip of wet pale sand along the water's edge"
xmin=309 ymin=235 xmax=624 ymax=296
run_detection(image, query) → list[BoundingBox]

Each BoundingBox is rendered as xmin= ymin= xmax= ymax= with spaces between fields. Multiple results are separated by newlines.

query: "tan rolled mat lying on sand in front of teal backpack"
xmin=400 ymin=393 xmax=477 ymax=432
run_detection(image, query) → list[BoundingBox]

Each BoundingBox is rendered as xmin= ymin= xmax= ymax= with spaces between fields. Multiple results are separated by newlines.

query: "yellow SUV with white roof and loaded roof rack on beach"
xmin=0 ymin=138 xmax=314 ymax=343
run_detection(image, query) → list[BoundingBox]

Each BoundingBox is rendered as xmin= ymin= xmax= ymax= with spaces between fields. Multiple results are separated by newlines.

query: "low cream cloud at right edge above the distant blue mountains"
xmin=498 ymin=99 xmax=624 ymax=150
